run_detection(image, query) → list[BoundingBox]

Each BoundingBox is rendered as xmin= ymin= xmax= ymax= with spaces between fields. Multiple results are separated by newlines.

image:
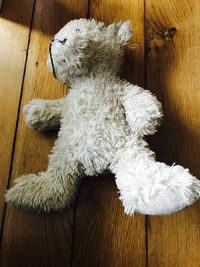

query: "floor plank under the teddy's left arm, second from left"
xmin=0 ymin=0 xmax=87 ymax=267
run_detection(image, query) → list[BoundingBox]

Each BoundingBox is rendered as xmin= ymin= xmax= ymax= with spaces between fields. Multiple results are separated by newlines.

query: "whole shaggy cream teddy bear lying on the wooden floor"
xmin=5 ymin=18 xmax=200 ymax=215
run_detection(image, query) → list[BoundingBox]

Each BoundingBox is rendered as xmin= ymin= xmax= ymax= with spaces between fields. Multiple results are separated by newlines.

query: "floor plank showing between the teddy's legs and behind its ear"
xmin=72 ymin=0 xmax=146 ymax=267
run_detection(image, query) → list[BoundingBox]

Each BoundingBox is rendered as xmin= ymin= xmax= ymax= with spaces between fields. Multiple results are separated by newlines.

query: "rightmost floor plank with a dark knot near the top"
xmin=145 ymin=0 xmax=200 ymax=267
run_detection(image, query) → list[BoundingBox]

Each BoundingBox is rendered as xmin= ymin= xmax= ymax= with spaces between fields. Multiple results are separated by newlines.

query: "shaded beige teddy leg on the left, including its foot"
xmin=5 ymin=139 xmax=80 ymax=212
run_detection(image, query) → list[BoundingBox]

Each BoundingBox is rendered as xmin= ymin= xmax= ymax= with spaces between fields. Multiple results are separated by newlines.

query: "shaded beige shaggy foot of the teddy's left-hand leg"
xmin=5 ymin=173 xmax=71 ymax=212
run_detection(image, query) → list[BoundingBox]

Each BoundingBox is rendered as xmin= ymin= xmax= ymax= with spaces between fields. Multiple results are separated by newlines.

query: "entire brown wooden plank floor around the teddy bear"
xmin=0 ymin=0 xmax=200 ymax=267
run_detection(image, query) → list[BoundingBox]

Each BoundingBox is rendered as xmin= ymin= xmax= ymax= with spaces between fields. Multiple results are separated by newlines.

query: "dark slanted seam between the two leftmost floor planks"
xmin=0 ymin=0 xmax=36 ymax=245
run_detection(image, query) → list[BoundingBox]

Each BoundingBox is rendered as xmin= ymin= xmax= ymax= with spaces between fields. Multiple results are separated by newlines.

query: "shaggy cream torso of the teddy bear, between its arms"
xmin=59 ymin=78 xmax=130 ymax=175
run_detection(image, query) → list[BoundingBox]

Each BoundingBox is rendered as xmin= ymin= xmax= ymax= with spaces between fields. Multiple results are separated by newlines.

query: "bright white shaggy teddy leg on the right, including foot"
xmin=111 ymin=137 xmax=200 ymax=215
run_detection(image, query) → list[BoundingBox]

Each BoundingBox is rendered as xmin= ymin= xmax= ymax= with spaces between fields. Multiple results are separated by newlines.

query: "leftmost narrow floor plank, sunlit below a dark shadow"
xmin=0 ymin=0 xmax=33 ymax=231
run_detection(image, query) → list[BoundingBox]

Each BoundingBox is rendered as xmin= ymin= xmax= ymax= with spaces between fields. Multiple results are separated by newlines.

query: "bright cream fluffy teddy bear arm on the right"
xmin=122 ymin=85 xmax=163 ymax=136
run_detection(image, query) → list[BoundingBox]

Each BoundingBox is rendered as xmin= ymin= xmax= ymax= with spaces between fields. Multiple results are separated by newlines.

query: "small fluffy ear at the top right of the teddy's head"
xmin=116 ymin=20 xmax=132 ymax=45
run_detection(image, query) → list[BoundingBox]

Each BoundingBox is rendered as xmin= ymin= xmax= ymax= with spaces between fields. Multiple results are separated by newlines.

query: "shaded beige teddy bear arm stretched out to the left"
xmin=23 ymin=98 xmax=64 ymax=131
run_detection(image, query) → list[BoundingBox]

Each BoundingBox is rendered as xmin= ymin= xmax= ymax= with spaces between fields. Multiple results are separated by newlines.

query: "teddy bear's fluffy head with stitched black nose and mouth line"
xmin=47 ymin=19 xmax=131 ymax=84
